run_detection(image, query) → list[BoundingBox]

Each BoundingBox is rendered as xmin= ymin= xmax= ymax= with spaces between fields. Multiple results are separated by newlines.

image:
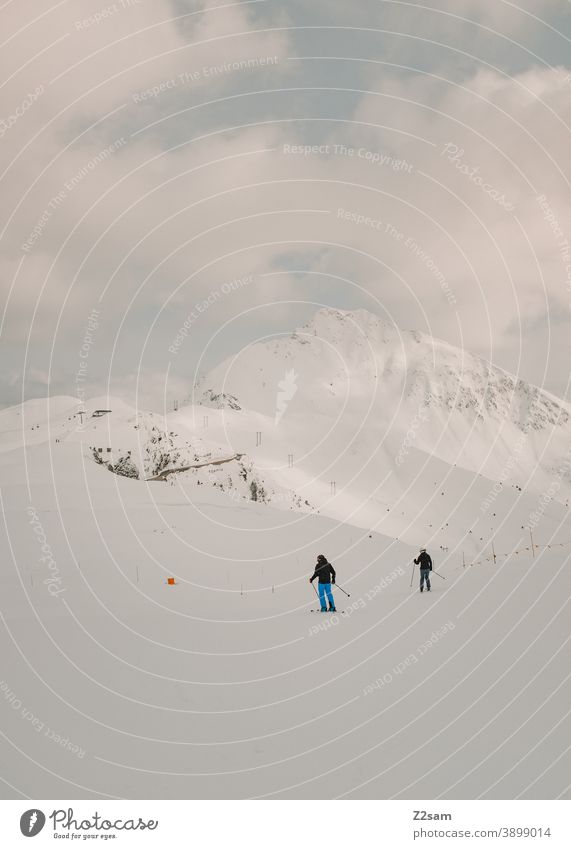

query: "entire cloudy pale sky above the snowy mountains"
xmin=0 ymin=0 xmax=571 ymax=409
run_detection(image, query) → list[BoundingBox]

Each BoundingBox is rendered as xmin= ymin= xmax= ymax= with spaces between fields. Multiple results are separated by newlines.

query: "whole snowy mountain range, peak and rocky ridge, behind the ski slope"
xmin=0 ymin=309 xmax=571 ymax=546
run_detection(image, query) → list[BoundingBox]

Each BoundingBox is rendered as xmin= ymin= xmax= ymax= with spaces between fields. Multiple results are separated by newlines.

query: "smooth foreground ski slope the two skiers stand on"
xmin=0 ymin=434 xmax=571 ymax=799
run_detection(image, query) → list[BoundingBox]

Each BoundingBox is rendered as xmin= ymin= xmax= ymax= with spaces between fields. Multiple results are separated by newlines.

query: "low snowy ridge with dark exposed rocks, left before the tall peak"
xmin=0 ymin=396 xmax=311 ymax=511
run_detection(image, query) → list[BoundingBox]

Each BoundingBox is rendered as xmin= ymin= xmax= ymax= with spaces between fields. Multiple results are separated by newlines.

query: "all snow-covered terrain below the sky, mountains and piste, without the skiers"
xmin=0 ymin=312 xmax=571 ymax=799
